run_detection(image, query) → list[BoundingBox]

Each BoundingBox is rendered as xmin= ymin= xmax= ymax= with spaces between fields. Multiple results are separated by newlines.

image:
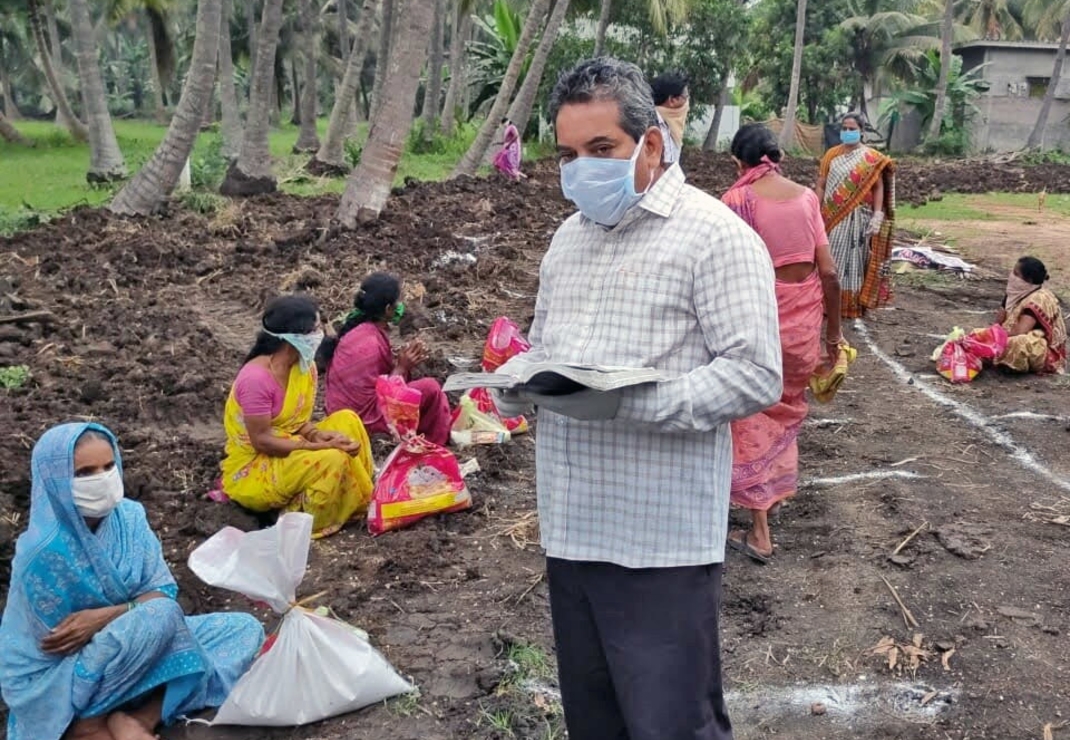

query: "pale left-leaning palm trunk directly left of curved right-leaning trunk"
xmin=68 ymin=0 xmax=126 ymax=183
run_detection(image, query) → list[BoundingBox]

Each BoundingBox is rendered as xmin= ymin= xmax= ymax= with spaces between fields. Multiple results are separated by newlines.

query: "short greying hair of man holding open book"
xmin=550 ymin=57 xmax=658 ymax=141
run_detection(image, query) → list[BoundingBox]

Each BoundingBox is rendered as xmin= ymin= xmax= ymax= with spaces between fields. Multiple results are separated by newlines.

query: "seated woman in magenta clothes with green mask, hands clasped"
xmin=319 ymin=273 xmax=449 ymax=445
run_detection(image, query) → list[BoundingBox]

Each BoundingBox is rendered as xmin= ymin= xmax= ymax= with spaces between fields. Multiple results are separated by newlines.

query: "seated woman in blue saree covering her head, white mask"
xmin=0 ymin=423 xmax=263 ymax=740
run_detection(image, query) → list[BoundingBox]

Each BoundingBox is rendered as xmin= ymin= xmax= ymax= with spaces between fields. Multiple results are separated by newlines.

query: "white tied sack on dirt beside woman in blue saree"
xmin=189 ymin=512 xmax=412 ymax=727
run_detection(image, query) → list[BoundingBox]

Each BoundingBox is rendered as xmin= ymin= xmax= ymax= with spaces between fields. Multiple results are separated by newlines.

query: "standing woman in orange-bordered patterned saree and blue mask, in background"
xmin=817 ymin=113 xmax=896 ymax=319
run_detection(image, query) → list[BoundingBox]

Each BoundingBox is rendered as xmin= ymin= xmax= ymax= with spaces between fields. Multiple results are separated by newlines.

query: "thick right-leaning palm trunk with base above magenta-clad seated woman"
xmin=337 ymin=0 xmax=434 ymax=228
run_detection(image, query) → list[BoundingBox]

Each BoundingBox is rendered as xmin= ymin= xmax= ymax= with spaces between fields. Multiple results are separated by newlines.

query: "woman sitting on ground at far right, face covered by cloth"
xmin=995 ymin=257 xmax=1067 ymax=374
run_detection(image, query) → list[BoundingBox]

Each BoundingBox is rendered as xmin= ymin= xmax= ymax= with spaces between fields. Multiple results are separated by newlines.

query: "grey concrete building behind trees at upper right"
xmin=954 ymin=41 xmax=1070 ymax=152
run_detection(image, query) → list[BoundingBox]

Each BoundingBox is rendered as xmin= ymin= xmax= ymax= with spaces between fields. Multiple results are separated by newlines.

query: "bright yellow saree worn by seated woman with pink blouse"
xmin=221 ymin=365 xmax=373 ymax=537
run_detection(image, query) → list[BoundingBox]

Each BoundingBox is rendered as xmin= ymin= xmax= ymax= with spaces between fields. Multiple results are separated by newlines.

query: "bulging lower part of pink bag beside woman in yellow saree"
xmin=368 ymin=436 xmax=472 ymax=535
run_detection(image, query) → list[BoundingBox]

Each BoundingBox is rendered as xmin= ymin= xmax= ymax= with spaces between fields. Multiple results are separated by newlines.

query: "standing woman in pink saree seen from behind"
xmin=721 ymin=124 xmax=842 ymax=564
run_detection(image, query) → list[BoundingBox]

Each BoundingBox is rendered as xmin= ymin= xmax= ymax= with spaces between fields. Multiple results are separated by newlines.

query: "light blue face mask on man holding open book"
xmin=561 ymin=134 xmax=646 ymax=227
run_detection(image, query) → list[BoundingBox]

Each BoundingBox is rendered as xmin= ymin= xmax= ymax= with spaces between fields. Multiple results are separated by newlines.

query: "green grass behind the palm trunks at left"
xmin=0 ymin=119 xmax=535 ymax=230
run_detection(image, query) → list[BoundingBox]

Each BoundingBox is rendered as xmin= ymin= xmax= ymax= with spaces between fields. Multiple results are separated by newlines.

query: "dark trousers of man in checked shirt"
xmin=547 ymin=558 xmax=732 ymax=740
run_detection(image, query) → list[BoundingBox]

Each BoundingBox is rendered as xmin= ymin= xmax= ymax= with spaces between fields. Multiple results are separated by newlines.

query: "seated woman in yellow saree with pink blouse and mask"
xmin=221 ymin=295 xmax=373 ymax=537
